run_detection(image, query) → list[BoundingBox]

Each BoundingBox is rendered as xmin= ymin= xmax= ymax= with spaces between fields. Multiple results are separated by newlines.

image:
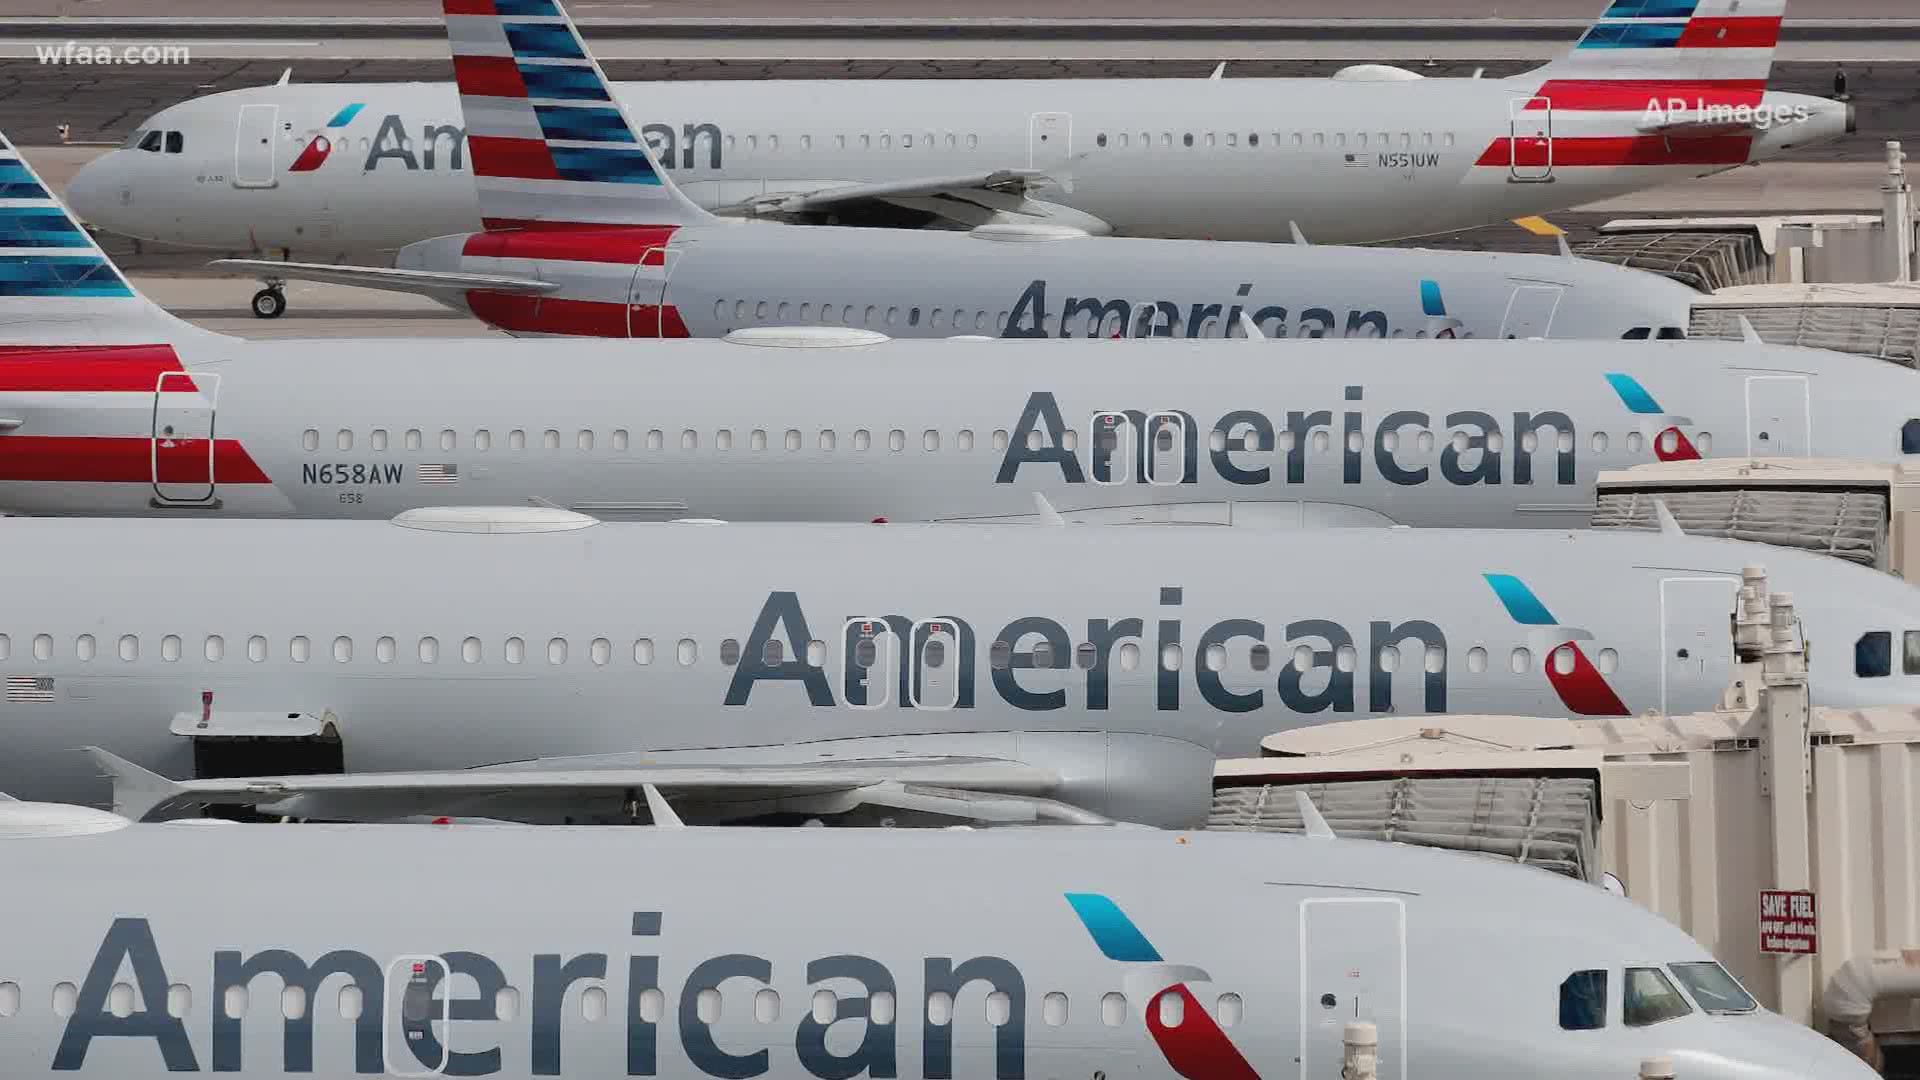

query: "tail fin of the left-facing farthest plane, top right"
xmin=1532 ymin=0 xmax=1788 ymax=89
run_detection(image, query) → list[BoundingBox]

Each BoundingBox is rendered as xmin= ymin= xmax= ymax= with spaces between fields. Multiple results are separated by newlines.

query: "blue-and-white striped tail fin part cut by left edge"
xmin=0 ymin=135 xmax=198 ymax=344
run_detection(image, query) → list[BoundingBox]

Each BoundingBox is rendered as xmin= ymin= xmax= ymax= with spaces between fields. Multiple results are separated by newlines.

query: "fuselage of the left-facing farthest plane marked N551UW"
xmin=69 ymin=75 xmax=1847 ymax=259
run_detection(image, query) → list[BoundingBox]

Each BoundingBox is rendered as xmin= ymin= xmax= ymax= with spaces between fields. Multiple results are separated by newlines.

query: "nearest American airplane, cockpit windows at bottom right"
xmin=0 ymin=801 xmax=1876 ymax=1080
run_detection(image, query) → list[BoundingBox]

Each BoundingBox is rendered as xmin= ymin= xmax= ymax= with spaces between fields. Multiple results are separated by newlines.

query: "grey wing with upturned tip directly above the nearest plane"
xmin=88 ymin=748 xmax=1106 ymax=824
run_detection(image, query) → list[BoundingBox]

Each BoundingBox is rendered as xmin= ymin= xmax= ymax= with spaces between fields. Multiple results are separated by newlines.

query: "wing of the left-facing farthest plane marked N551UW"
xmin=716 ymin=169 xmax=1112 ymax=233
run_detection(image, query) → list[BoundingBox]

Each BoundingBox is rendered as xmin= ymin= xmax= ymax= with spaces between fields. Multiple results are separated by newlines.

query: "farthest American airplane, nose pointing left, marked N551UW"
xmin=67 ymin=0 xmax=1855 ymax=261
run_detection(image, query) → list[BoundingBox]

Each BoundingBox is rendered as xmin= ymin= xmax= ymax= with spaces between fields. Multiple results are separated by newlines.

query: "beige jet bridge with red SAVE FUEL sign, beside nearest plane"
xmin=1210 ymin=567 xmax=1920 ymax=1053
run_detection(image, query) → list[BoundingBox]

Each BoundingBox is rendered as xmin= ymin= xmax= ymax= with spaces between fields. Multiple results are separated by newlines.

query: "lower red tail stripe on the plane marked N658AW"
xmin=0 ymin=434 xmax=273 ymax=484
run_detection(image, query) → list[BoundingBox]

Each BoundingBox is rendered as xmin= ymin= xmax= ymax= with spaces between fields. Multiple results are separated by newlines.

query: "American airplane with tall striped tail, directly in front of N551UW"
xmin=191 ymin=0 xmax=1695 ymax=338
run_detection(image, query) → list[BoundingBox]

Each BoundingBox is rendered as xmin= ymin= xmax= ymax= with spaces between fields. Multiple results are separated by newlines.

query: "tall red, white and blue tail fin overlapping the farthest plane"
xmin=442 ymin=0 xmax=712 ymax=231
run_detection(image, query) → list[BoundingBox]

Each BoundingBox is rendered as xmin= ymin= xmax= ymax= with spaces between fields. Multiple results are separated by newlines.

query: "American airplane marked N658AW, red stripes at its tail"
xmin=0 ymin=142 xmax=1920 ymax=527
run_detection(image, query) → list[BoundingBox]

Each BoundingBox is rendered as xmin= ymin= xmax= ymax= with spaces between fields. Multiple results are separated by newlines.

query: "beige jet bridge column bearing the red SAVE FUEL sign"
xmin=1758 ymin=567 xmax=1812 ymax=1024
